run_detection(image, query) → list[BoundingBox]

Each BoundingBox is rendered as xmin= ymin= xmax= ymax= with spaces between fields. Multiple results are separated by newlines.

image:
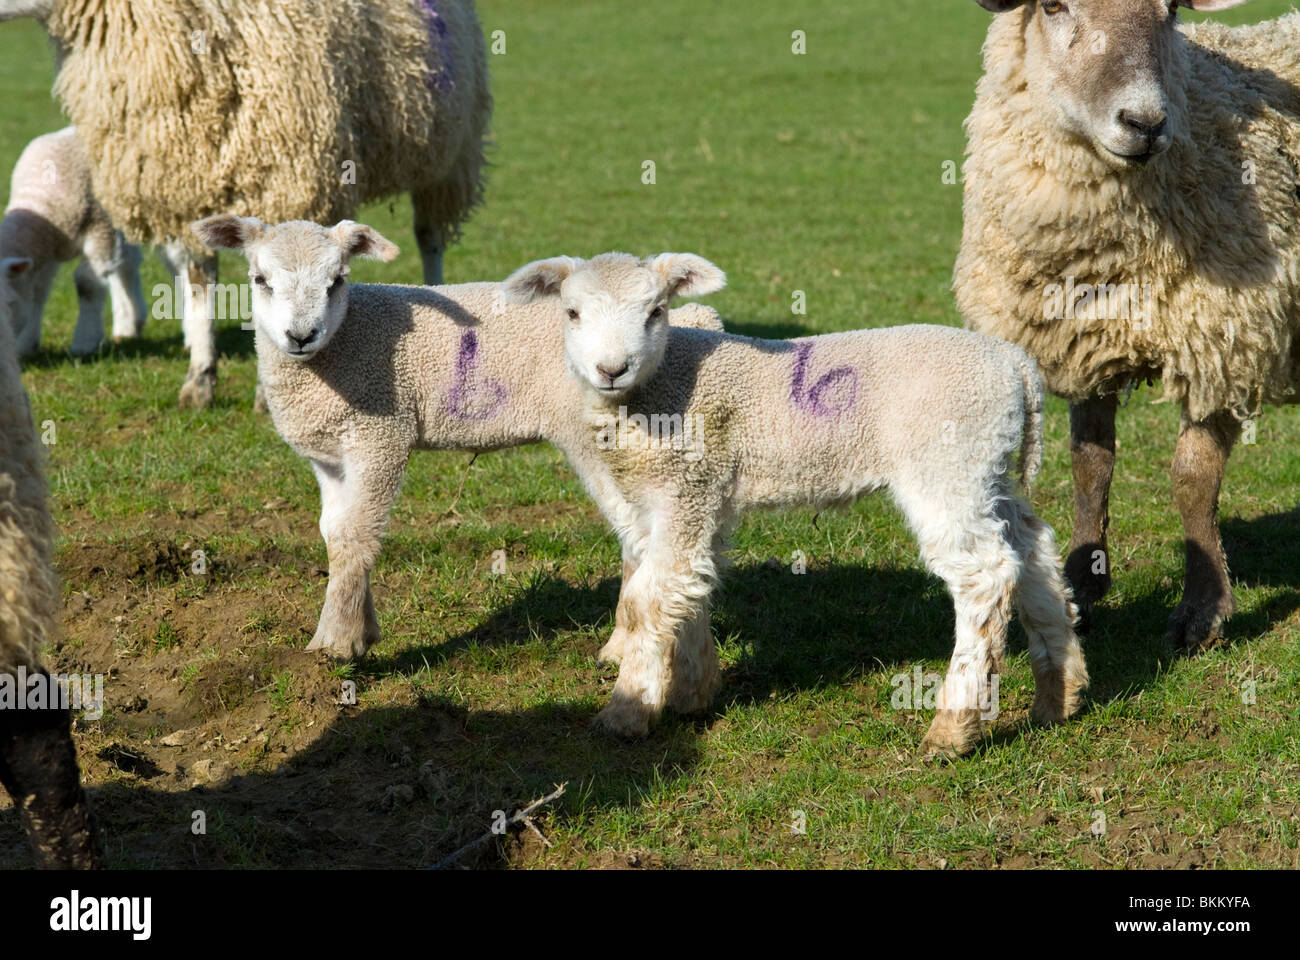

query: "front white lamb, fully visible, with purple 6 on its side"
xmin=506 ymin=254 xmax=1087 ymax=757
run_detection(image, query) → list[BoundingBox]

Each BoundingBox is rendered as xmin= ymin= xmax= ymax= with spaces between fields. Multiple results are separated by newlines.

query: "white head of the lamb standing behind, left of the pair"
xmin=191 ymin=215 xmax=398 ymax=360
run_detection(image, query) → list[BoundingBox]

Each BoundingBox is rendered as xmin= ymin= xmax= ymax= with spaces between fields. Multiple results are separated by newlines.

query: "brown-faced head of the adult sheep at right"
xmin=976 ymin=0 xmax=1245 ymax=168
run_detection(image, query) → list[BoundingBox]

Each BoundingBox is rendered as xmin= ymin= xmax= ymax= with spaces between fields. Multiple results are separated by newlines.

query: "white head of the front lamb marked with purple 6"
xmin=503 ymin=254 xmax=727 ymax=399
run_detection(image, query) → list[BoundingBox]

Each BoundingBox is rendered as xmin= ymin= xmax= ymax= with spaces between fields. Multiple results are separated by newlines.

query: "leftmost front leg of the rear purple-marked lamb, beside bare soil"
xmin=307 ymin=460 xmax=406 ymax=660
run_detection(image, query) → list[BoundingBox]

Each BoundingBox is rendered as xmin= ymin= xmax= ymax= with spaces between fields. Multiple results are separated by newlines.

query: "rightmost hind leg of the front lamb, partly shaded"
xmin=1000 ymin=498 xmax=1088 ymax=725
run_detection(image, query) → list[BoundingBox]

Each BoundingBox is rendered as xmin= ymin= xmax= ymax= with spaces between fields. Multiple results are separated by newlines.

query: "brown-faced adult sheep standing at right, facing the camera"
xmin=954 ymin=0 xmax=1300 ymax=652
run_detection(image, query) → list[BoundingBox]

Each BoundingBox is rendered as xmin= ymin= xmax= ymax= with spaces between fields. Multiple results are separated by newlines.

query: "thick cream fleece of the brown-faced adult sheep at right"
xmin=954 ymin=7 xmax=1300 ymax=420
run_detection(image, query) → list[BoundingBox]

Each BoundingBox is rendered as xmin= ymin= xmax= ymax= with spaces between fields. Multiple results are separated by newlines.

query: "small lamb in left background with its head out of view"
xmin=0 ymin=126 xmax=146 ymax=356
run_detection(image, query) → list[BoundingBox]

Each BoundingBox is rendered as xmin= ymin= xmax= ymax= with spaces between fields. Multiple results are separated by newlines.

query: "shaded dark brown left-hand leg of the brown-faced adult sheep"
xmin=1065 ymin=394 xmax=1119 ymax=633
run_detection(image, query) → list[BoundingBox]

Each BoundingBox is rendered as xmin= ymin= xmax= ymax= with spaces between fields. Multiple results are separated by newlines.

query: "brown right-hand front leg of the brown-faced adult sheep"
xmin=1166 ymin=412 xmax=1240 ymax=653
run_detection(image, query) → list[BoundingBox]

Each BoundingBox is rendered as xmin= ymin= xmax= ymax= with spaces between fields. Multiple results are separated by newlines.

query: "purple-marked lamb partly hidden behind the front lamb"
xmin=194 ymin=215 xmax=722 ymax=660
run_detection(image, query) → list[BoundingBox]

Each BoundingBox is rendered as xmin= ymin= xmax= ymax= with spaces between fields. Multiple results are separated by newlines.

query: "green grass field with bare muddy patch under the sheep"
xmin=0 ymin=0 xmax=1300 ymax=868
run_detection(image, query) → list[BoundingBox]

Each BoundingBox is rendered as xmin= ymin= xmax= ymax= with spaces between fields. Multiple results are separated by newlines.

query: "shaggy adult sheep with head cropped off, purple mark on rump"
xmin=0 ymin=0 xmax=491 ymax=408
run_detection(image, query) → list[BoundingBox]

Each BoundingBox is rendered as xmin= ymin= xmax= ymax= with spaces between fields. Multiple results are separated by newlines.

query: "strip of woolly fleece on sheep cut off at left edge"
xmin=0 ymin=278 xmax=59 ymax=673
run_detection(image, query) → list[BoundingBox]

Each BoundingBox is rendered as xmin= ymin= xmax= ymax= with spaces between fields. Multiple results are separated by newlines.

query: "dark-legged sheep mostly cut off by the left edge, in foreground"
xmin=0 ymin=258 xmax=101 ymax=869
